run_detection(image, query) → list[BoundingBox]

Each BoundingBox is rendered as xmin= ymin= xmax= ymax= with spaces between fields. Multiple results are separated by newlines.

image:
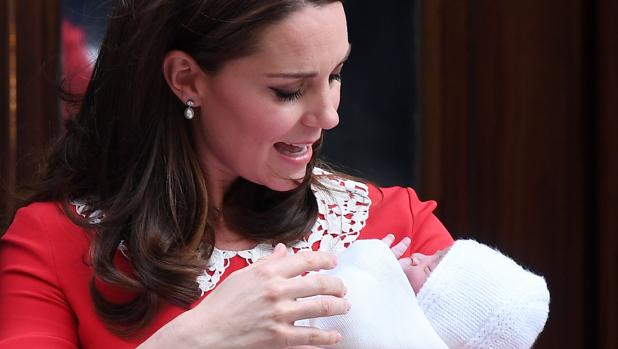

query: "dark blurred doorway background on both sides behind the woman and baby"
xmin=0 ymin=0 xmax=618 ymax=349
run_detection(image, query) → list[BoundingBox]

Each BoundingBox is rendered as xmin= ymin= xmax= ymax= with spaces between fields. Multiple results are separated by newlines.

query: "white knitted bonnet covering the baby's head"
xmin=417 ymin=240 xmax=549 ymax=349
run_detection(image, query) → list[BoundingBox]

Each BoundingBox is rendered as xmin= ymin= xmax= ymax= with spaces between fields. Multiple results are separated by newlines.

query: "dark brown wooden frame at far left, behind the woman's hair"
xmin=0 ymin=0 xmax=60 ymax=228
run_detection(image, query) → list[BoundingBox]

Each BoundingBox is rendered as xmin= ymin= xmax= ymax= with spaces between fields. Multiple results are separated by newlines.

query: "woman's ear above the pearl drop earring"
xmin=163 ymin=50 xmax=205 ymax=107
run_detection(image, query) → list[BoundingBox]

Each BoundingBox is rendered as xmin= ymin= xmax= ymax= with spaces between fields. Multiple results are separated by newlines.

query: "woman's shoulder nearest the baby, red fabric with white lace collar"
xmin=316 ymin=173 xmax=453 ymax=255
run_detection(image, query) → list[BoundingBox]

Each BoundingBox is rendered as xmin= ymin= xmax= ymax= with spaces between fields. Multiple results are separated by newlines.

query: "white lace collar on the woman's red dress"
xmin=72 ymin=169 xmax=371 ymax=294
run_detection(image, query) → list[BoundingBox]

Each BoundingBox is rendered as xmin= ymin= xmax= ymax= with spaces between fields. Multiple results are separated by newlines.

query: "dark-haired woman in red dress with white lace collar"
xmin=0 ymin=0 xmax=452 ymax=349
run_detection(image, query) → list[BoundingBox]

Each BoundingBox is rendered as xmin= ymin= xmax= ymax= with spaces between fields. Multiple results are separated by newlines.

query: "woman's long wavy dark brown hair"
xmin=31 ymin=0 xmax=340 ymax=334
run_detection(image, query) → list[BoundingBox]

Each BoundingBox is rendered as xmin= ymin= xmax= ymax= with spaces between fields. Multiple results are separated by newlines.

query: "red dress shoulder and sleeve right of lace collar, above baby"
xmin=360 ymin=185 xmax=453 ymax=257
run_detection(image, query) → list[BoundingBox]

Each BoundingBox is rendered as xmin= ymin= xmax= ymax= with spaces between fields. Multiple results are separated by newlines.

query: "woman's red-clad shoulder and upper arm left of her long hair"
xmin=0 ymin=202 xmax=127 ymax=348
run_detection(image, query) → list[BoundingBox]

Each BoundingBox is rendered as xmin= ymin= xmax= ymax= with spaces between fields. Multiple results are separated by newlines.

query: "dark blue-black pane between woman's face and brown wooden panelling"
xmin=323 ymin=0 xmax=418 ymax=185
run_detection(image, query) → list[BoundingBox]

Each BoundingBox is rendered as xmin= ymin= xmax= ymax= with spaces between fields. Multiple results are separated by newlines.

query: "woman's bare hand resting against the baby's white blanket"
xmin=140 ymin=244 xmax=350 ymax=349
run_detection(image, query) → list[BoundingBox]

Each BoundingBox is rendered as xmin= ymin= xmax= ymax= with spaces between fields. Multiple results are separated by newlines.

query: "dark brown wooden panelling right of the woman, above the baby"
xmin=421 ymin=0 xmax=618 ymax=349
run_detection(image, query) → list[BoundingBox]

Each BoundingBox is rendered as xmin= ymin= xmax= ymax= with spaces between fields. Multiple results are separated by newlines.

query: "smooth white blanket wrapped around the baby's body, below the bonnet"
xmin=296 ymin=240 xmax=447 ymax=349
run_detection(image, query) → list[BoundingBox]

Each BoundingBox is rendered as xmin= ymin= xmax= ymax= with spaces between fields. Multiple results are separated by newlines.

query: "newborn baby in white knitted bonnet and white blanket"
xmin=297 ymin=236 xmax=549 ymax=349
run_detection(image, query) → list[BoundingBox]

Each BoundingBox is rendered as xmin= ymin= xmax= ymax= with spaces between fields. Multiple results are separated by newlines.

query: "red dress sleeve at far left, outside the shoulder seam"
xmin=0 ymin=205 xmax=79 ymax=349
